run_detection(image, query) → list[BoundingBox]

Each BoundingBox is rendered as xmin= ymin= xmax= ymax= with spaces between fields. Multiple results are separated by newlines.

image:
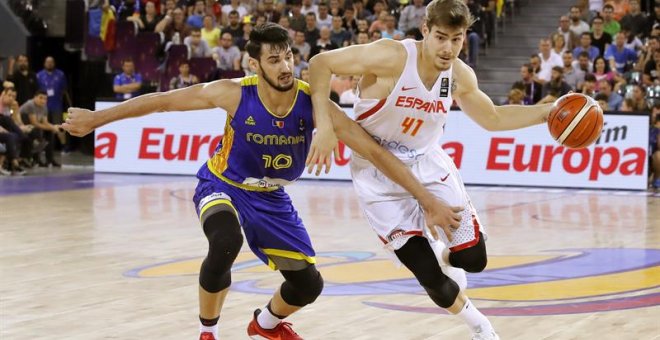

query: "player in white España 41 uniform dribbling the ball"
xmin=310 ymin=0 xmax=551 ymax=339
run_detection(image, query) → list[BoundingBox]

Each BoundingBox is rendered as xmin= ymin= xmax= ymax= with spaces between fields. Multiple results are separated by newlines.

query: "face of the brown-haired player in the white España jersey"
xmin=422 ymin=24 xmax=465 ymax=70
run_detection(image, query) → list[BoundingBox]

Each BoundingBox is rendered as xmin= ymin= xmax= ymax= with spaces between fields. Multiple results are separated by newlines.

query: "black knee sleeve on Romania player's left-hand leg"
xmin=199 ymin=211 xmax=243 ymax=293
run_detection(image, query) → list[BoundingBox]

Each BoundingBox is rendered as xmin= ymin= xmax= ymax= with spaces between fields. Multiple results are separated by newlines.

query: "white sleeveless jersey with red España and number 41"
xmin=354 ymin=39 xmax=452 ymax=165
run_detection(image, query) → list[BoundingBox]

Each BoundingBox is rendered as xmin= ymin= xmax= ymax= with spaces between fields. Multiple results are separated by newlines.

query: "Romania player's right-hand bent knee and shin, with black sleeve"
xmin=270 ymin=262 xmax=323 ymax=317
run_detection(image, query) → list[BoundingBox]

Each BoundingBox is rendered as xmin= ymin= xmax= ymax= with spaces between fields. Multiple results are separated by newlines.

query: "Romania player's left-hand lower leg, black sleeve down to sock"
xmin=199 ymin=209 xmax=243 ymax=319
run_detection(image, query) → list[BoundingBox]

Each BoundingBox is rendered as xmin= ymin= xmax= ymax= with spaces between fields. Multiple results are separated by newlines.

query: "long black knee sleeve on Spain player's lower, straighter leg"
xmin=395 ymin=236 xmax=460 ymax=308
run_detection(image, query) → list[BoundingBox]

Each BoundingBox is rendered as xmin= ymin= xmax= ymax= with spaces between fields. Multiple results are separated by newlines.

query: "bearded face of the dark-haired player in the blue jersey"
xmin=257 ymin=44 xmax=294 ymax=92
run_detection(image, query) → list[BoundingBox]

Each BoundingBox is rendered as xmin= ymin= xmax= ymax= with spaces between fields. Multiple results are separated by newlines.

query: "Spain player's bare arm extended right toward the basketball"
xmin=452 ymin=60 xmax=552 ymax=131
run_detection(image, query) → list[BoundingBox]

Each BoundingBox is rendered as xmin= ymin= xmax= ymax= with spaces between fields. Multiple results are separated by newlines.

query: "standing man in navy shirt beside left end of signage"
xmin=37 ymin=56 xmax=71 ymax=124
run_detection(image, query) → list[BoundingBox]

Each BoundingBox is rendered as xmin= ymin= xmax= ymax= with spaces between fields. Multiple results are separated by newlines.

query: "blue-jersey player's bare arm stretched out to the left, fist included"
xmin=62 ymin=79 xmax=241 ymax=137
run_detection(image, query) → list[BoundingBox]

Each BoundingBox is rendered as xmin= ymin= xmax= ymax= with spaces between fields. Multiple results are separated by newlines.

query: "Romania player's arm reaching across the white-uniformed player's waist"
xmin=328 ymin=99 xmax=463 ymax=240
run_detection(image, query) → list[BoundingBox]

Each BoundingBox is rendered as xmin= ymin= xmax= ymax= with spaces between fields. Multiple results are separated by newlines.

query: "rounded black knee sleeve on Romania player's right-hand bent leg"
xmin=280 ymin=264 xmax=323 ymax=307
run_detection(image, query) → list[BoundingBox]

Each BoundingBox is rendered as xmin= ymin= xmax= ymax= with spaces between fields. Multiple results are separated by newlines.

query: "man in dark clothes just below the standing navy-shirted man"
xmin=20 ymin=90 xmax=63 ymax=168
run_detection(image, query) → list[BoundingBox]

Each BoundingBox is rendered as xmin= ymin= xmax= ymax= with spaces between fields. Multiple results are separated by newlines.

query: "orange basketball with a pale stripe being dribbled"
xmin=548 ymin=93 xmax=603 ymax=149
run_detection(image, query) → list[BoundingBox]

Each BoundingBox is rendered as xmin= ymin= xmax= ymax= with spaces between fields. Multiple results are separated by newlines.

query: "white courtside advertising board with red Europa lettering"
xmin=95 ymin=102 xmax=649 ymax=190
